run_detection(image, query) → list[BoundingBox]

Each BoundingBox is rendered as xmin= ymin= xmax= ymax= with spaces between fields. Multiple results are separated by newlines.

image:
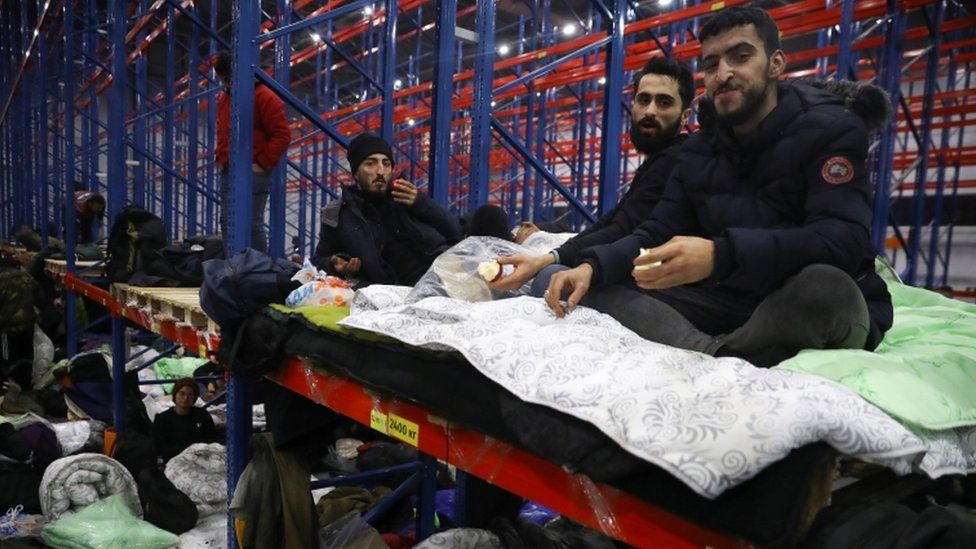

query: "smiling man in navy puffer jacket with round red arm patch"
xmin=546 ymin=8 xmax=892 ymax=366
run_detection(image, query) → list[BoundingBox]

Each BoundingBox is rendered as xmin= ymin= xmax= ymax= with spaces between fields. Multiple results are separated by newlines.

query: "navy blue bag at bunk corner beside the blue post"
xmin=200 ymin=249 xmax=299 ymax=331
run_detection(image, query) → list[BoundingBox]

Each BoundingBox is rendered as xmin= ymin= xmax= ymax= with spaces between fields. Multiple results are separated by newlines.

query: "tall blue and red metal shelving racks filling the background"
xmin=0 ymin=0 xmax=976 ymax=544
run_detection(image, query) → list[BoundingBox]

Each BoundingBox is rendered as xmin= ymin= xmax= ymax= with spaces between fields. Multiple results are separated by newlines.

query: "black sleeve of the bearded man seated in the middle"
xmin=556 ymin=135 xmax=687 ymax=267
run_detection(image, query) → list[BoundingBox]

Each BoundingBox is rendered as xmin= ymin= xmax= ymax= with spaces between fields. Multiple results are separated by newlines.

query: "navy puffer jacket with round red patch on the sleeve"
xmin=584 ymin=81 xmax=892 ymax=348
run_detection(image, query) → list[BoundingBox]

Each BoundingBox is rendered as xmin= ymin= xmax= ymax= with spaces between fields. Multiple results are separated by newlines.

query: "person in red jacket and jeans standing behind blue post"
xmin=214 ymin=52 xmax=291 ymax=253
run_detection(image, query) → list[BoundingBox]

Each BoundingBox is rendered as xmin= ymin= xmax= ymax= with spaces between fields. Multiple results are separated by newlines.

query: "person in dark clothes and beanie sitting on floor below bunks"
xmin=153 ymin=377 xmax=216 ymax=461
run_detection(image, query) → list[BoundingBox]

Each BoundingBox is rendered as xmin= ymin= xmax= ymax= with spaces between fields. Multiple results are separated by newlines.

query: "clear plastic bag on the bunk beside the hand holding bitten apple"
xmin=406 ymin=236 xmax=534 ymax=303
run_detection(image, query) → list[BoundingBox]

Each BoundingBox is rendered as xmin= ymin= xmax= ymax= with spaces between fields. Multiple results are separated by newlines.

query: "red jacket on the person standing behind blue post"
xmin=217 ymin=84 xmax=291 ymax=170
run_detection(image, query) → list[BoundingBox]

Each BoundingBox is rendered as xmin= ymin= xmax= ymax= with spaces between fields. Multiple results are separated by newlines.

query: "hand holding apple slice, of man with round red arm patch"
xmin=632 ymin=236 xmax=715 ymax=290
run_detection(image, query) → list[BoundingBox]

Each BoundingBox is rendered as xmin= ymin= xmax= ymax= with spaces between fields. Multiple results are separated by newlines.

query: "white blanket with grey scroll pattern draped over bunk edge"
xmin=341 ymin=286 xmax=976 ymax=498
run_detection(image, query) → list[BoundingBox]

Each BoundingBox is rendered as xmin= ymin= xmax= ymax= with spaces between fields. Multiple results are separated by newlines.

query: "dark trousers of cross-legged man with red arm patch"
xmin=580 ymin=265 xmax=870 ymax=367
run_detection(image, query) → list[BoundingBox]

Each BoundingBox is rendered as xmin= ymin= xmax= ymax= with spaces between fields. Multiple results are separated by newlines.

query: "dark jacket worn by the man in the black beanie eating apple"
xmin=312 ymin=187 xmax=461 ymax=285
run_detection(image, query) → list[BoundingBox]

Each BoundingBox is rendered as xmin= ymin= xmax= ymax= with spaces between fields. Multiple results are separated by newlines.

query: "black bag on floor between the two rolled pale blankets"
xmin=135 ymin=467 xmax=199 ymax=535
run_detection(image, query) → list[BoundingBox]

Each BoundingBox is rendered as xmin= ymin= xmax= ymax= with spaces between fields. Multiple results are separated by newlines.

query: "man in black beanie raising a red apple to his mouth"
xmin=312 ymin=133 xmax=461 ymax=286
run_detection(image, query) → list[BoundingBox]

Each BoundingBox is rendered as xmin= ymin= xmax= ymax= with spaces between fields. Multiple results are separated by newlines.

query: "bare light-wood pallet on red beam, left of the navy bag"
xmin=112 ymin=284 xmax=220 ymax=333
